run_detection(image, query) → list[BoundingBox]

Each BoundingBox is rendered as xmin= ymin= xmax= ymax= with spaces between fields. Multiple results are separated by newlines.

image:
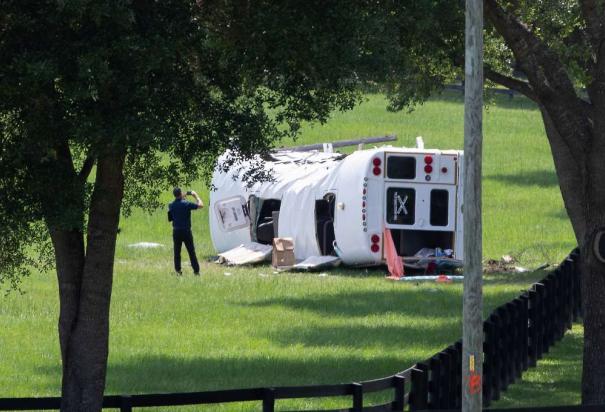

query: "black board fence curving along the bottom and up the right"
xmin=0 ymin=250 xmax=580 ymax=412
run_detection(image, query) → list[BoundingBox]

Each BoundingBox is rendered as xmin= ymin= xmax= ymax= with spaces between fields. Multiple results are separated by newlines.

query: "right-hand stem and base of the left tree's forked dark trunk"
xmin=60 ymin=154 xmax=124 ymax=411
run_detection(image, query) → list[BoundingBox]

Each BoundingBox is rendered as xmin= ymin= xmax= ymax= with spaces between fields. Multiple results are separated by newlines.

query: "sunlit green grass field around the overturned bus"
xmin=0 ymin=94 xmax=582 ymax=410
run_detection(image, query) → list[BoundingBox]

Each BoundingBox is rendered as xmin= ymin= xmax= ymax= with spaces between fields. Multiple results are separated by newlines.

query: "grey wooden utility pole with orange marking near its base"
xmin=462 ymin=0 xmax=483 ymax=412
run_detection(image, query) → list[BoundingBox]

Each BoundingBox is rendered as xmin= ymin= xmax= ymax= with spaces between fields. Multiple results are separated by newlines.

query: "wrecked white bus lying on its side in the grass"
xmin=209 ymin=138 xmax=463 ymax=265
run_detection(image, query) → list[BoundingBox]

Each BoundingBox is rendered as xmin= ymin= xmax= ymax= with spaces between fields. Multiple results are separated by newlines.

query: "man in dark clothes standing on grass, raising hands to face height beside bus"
xmin=168 ymin=187 xmax=204 ymax=276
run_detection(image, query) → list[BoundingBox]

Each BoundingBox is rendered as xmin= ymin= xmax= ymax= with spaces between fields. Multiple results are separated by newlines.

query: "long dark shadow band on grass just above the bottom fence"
xmin=33 ymin=353 xmax=417 ymax=395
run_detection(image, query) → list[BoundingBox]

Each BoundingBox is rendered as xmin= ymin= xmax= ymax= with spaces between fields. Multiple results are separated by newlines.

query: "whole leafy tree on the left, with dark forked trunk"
xmin=0 ymin=0 xmax=462 ymax=410
